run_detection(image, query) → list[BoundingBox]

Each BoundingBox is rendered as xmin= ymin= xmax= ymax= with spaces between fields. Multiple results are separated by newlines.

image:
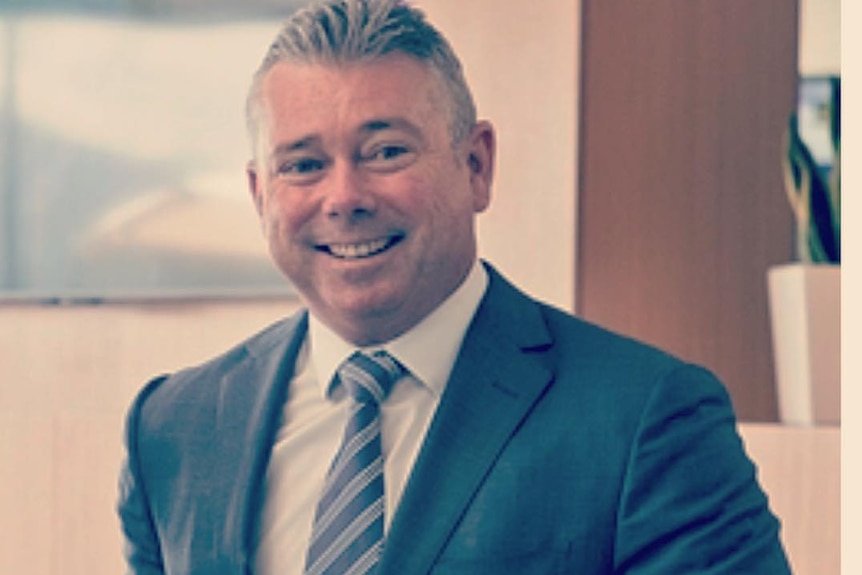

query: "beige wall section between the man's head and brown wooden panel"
xmin=417 ymin=0 xmax=580 ymax=310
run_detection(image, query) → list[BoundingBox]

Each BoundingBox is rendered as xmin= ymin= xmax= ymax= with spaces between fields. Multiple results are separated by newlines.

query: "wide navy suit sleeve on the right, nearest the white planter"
xmin=615 ymin=366 xmax=790 ymax=575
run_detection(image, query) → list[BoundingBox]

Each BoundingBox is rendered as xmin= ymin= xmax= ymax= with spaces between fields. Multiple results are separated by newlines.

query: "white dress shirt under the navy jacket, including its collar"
xmin=255 ymin=262 xmax=488 ymax=575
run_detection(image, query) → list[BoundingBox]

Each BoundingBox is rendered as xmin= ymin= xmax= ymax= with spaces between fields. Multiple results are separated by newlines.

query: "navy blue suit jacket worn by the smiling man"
xmin=119 ymin=264 xmax=789 ymax=575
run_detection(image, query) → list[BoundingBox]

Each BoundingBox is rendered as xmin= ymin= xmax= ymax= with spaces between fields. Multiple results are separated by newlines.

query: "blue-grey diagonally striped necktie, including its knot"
xmin=305 ymin=351 xmax=403 ymax=575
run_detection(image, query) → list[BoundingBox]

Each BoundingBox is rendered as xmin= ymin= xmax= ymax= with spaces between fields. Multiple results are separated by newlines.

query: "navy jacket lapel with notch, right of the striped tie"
xmin=379 ymin=270 xmax=553 ymax=575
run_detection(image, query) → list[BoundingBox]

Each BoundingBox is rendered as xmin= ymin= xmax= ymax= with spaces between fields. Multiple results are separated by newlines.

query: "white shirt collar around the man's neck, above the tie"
xmin=308 ymin=261 xmax=488 ymax=396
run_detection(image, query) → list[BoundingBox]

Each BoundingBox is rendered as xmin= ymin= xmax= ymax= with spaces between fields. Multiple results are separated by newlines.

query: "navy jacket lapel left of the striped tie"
xmin=211 ymin=313 xmax=307 ymax=569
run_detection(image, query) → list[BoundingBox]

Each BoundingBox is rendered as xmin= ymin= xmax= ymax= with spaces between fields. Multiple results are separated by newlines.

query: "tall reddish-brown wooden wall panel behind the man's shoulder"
xmin=576 ymin=0 xmax=798 ymax=420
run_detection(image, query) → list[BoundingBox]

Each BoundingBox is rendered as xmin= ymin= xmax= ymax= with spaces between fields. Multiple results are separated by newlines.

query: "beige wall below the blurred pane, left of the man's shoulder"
xmin=0 ymin=299 xmax=297 ymax=575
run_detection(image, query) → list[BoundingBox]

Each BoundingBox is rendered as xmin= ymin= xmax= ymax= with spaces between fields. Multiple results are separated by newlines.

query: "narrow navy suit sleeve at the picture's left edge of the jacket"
xmin=117 ymin=378 xmax=165 ymax=575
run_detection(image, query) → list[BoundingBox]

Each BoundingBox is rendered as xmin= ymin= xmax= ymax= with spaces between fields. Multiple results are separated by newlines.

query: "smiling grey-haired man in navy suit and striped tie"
xmin=119 ymin=0 xmax=789 ymax=575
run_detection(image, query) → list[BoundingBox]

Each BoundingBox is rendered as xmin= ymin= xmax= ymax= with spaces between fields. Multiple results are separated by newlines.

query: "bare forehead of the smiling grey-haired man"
xmin=261 ymin=54 xmax=448 ymax=143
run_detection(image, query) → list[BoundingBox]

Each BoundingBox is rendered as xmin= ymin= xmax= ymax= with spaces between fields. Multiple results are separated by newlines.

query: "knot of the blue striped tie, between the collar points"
xmin=338 ymin=351 xmax=404 ymax=403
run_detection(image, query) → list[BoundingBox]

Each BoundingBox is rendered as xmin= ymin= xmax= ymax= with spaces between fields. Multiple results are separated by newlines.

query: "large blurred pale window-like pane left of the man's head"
xmin=0 ymin=0 xmax=304 ymax=298
